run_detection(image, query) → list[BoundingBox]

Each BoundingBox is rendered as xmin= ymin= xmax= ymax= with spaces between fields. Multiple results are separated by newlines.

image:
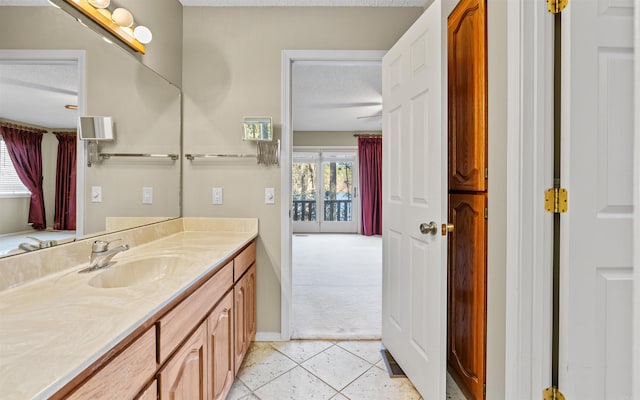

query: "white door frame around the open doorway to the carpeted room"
xmin=280 ymin=50 xmax=387 ymax=341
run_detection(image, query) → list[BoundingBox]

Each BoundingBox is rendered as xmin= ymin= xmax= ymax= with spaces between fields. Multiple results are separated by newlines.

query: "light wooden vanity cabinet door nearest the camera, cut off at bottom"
xmin=160 ymin=323 xmax=209 ymax=400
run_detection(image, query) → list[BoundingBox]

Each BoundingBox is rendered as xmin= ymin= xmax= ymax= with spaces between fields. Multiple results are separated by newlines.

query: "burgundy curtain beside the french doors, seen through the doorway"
xmin=358 ymin=137 xmax=382 ymax=236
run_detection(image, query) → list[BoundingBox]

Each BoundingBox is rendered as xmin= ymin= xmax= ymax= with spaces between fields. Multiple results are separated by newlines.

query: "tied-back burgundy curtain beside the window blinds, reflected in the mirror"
xmin=0 ymin=124 xmax=47 ymax=229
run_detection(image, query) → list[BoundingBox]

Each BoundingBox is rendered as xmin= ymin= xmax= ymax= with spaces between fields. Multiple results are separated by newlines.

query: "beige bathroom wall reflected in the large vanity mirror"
xmin=0 ymin=7 xmax=181 ymax=233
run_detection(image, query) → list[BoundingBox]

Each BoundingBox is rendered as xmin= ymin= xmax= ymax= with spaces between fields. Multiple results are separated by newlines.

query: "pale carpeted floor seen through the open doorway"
xmin=292 ymin=234 xmax=382 ymax=340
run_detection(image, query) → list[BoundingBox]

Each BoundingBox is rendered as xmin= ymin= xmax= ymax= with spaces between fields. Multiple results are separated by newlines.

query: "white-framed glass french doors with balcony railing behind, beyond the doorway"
xmin=291 ymin=150 xmax=360 ymax=233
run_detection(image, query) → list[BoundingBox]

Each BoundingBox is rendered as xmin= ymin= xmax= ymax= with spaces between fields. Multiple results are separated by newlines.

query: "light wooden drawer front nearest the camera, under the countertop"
xmin=68 ymin=328 xmax=156 ymax=400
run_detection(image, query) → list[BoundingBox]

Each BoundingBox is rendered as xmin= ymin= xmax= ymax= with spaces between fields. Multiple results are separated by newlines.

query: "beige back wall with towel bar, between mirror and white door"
xmin=182 ymin=7 xmax=422 ymax=332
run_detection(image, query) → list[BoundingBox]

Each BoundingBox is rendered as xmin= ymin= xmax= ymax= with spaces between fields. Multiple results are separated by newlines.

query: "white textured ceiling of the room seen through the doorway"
xmin=292 ymin=62 xmax=382 ymax=131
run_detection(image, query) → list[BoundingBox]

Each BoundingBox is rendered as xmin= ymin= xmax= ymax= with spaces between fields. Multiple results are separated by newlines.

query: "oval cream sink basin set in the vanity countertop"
xmin=89 ymin=255 xmax=192 ymax=288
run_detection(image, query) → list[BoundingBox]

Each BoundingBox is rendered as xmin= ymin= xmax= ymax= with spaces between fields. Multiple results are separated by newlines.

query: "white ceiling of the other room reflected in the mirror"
xmin=0 ymin=60 xmax=78 ymax=128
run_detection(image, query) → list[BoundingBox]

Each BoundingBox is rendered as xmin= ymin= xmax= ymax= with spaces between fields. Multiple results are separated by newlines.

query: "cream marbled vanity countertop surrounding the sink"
xmin=0 ymin=230 xmax=257 ymax=400
